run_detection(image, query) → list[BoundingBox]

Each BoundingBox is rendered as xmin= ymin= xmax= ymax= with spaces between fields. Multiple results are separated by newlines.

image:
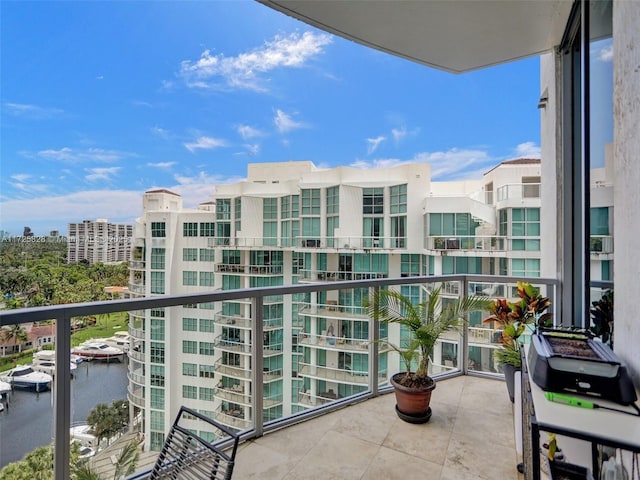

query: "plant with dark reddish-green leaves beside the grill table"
xmin=483 ymin=282 xmax=553 ymax=402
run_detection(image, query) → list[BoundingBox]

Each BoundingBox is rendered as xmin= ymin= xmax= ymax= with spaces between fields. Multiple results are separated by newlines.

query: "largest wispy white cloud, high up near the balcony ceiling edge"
xmin=180 ymin=32 xmax=332 ymax=91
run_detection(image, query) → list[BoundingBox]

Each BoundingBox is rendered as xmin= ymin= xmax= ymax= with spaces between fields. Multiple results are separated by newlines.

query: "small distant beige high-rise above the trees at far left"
xmin=67 ymin=218 xmax=133 ymax=263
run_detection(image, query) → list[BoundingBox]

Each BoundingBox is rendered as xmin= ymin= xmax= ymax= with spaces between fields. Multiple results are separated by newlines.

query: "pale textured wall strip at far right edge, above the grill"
xmin=613 ymin=0 xmax=640 ymax=388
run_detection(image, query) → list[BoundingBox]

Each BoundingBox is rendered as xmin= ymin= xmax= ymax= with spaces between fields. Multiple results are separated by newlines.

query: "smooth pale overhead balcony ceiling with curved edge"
xmin=258 ymin=0 xmax=573 ymax=73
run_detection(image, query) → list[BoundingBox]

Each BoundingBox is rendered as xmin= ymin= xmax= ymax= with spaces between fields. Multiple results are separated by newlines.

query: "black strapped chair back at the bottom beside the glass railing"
xmin=149 ymin=406 xmax=240 ymax=480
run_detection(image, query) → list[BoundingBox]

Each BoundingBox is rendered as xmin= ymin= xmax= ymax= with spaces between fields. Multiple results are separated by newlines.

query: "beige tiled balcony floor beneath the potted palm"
xmin=233 ymin=376 xmax=522 ymax=480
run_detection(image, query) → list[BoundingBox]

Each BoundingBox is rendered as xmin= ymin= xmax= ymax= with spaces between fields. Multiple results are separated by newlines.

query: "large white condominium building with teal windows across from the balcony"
xmin=129 ymin=159 xmax=606 ymax=449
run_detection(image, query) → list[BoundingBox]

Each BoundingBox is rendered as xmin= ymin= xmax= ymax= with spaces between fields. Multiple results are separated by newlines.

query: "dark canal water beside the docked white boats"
xmin=0 ymin=362 xmax=127 ymax=468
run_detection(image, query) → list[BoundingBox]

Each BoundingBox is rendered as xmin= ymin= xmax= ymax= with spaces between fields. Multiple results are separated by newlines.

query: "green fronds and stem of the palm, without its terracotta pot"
xmin=365 ymin=286 xmax=489 ymax=388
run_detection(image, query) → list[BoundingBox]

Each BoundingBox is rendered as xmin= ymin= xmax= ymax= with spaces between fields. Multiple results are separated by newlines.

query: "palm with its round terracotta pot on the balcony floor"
xmin=366 ymin=286 xmax=489 ymax=423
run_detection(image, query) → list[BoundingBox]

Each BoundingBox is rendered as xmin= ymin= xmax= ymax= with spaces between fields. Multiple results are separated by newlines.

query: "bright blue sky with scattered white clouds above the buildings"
xmin=0 ymin=1 xmax=540 ymax=235
